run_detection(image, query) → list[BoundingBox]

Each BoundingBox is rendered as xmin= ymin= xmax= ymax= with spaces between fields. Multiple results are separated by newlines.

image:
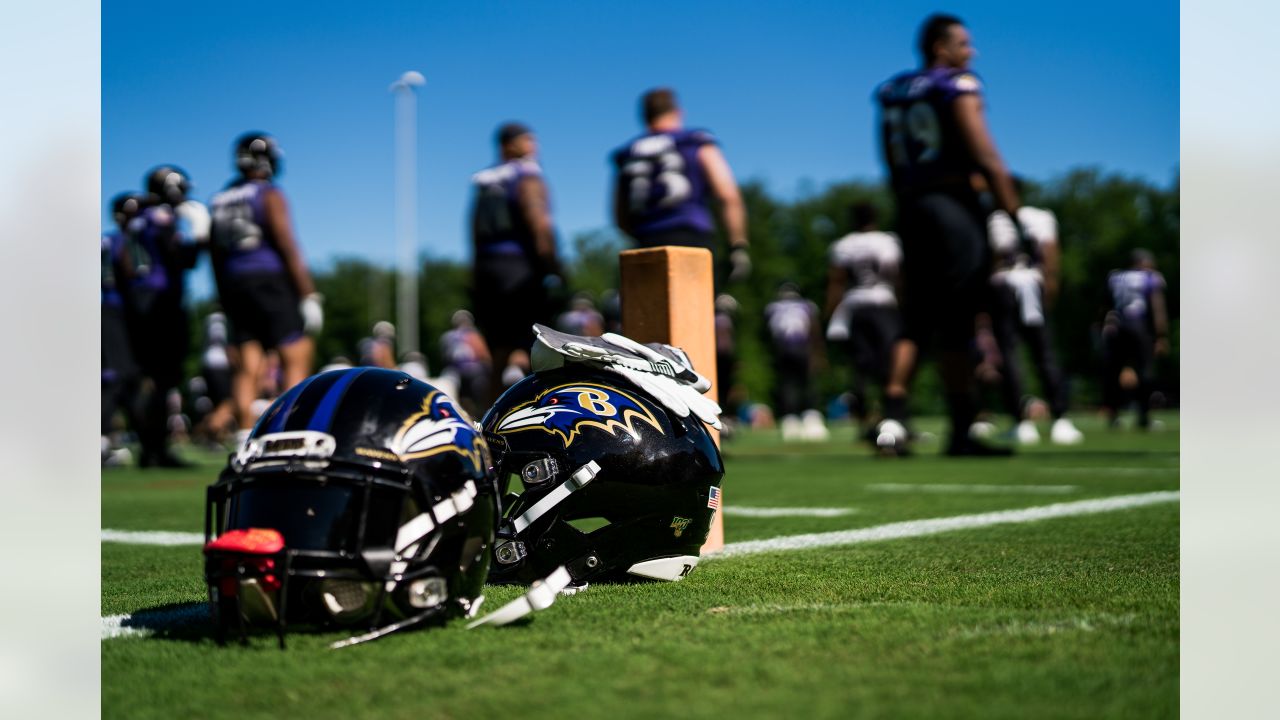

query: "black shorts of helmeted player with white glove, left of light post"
xmin=218 ymin=273 xmax=302 ymax=350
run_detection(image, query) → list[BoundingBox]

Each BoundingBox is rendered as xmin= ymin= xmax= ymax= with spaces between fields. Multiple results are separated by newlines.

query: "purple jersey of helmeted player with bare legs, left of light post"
xmin=209 ymin=179 xmax=284 ymax=277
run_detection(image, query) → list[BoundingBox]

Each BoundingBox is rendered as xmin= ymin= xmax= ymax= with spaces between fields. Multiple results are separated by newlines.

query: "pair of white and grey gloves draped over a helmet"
xmin=531 ymin=324 xmax=721 ymax=429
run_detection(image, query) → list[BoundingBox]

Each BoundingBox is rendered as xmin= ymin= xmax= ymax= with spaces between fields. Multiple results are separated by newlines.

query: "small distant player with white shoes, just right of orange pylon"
xmin=764 ymin=282 xmax=828 ymax=442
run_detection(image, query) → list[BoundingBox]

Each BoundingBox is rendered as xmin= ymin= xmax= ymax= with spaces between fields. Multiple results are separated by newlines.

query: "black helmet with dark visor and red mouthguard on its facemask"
xmin=205 ymin=368 xmax=498 ymax=647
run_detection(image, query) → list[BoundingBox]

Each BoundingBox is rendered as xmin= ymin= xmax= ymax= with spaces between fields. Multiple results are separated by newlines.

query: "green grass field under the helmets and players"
xmin=101 ymin=414 xmax=1179 ymax=719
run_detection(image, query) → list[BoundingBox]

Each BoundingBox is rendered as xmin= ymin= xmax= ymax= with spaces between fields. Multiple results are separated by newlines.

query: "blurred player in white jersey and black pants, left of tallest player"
xmin=824 ymin=202 xmax=902 ymax=437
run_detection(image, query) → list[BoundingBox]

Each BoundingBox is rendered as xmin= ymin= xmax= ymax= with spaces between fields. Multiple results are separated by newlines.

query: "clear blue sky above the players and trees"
xmin=102 ymin=0 xmax=1179 ymax=295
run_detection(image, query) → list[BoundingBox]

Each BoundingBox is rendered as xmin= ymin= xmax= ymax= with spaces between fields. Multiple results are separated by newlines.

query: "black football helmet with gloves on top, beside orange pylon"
xmin=481 ymin=364 xmax=724 ymax=584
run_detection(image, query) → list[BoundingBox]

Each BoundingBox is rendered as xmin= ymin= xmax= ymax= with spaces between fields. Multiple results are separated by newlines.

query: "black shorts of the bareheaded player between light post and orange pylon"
xmin=472 ymin=254 xmax=552 ymax=353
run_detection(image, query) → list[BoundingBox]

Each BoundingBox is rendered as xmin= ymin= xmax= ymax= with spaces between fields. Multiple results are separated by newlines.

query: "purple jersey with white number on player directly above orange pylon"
xmin=613 ymin=129 xmax=716 ymax=236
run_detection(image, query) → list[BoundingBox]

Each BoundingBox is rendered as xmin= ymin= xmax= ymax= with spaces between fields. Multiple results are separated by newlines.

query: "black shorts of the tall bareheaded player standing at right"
xmin=897 ymin=192 xmax=991 ymax=350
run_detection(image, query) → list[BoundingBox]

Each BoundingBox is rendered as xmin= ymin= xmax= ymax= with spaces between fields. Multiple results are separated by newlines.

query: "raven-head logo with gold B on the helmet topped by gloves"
xmin=495 ymin=383 xmax=663 ymax=447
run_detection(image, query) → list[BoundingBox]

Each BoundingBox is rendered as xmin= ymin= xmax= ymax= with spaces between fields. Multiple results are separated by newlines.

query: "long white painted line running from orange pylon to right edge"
xmin=704 ymin=491 xmax=1180 ymax=560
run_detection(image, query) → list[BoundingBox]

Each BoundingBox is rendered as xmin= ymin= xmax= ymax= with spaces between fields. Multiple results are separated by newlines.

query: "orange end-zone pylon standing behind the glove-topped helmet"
xmin=620 ymin=247 xmax=724 ymax=552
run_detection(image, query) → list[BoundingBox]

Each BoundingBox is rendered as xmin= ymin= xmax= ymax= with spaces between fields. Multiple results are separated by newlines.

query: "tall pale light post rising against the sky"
xmin=389 ymin=70 xmax=426 ymax=354
